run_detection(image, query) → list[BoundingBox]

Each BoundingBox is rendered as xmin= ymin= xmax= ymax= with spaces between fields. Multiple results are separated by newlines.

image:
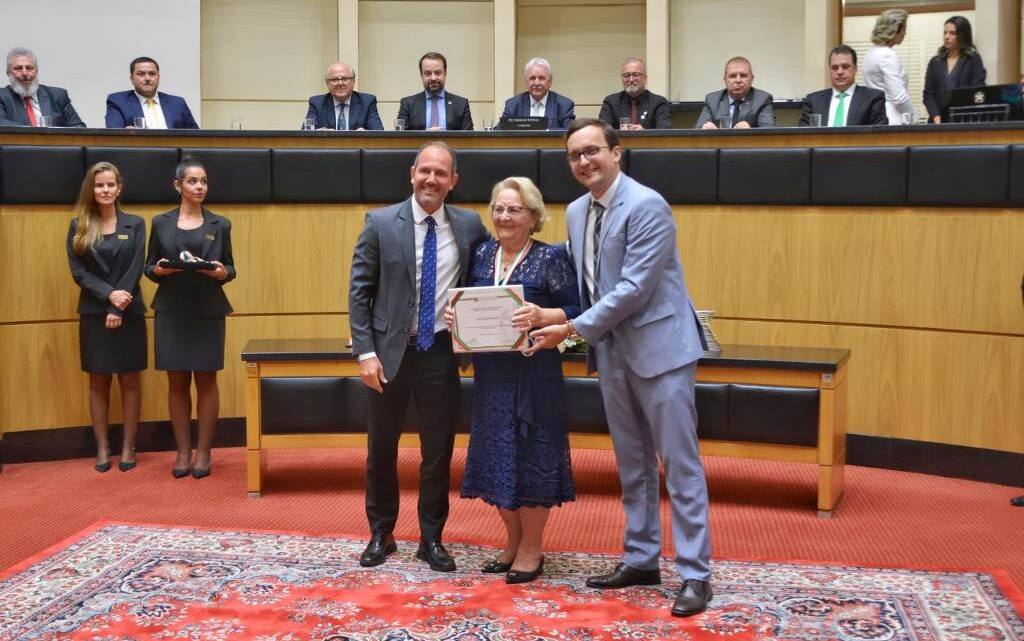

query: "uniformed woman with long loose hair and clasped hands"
xmin=68 ymin=163 xmax=146 ymax=472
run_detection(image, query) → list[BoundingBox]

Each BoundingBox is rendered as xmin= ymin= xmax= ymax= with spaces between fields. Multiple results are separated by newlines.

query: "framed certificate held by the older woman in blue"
xmin=449 ymin=285 xmax=526 ymax=353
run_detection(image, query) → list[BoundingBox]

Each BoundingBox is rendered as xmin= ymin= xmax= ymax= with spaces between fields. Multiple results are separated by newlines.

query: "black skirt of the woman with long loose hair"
xmin=78 ymin=313 xmax=146 ymax=374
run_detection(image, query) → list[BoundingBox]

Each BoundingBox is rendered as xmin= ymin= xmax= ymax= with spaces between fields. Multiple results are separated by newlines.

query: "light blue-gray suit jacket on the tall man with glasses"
xmin=565 ymin=174 xmax=703 ymax=378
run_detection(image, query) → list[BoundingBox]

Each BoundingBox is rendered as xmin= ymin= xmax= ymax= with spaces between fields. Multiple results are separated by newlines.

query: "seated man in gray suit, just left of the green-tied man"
xmin=695 ymin=55 xmax=775 ymax=129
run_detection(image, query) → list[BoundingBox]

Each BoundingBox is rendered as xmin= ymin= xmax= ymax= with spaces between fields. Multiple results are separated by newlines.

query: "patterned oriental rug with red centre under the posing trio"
xmin=0 ymin=522 xmax=1024 ymax=641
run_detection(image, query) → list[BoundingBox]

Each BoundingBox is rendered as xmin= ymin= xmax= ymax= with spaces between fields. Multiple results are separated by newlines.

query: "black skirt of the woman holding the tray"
xmin=155 ymin=311 xmax=224 ymax=372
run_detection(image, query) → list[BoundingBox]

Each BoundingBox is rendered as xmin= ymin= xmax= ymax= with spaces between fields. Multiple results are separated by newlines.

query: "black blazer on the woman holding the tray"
xmin=145 ymin=207 xmax=236 ymax=318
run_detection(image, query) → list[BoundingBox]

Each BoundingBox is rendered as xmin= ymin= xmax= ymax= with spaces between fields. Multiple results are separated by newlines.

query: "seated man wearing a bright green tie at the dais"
xmin=800 ymin=44 xmax=889 ymax=127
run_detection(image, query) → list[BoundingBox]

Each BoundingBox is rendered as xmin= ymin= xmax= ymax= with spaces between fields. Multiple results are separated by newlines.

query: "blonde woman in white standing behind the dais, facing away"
xmin=863 ymin=9 xmax=916 ymax=125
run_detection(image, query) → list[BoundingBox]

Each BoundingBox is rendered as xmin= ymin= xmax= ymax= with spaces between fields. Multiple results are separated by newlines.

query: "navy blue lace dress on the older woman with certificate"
xmin=462 ymin=241 xmax=580 ymax=510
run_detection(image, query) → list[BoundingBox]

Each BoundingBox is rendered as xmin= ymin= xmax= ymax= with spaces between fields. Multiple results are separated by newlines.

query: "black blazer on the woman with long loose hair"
xmin=67 ymin=211 xmax=145 ymax=316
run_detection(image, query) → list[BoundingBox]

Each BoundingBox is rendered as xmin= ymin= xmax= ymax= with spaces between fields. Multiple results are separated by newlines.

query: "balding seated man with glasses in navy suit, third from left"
xmin=306 ymin=60 xmax=384 ymax=131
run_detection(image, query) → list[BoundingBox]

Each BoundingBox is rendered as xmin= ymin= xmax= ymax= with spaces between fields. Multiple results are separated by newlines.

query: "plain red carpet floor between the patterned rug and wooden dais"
xmin=0 ymin=448 xmax=1024 ymax=586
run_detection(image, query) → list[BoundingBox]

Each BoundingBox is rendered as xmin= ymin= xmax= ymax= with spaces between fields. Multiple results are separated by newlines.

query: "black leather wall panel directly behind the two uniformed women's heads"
xmin=85 ymin=146 xmax=180 ymax=205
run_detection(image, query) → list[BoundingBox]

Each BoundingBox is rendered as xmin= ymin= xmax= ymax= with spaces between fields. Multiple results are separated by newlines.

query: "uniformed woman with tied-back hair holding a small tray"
xmin=145 ymin=156 xmax=234 ymax=478
